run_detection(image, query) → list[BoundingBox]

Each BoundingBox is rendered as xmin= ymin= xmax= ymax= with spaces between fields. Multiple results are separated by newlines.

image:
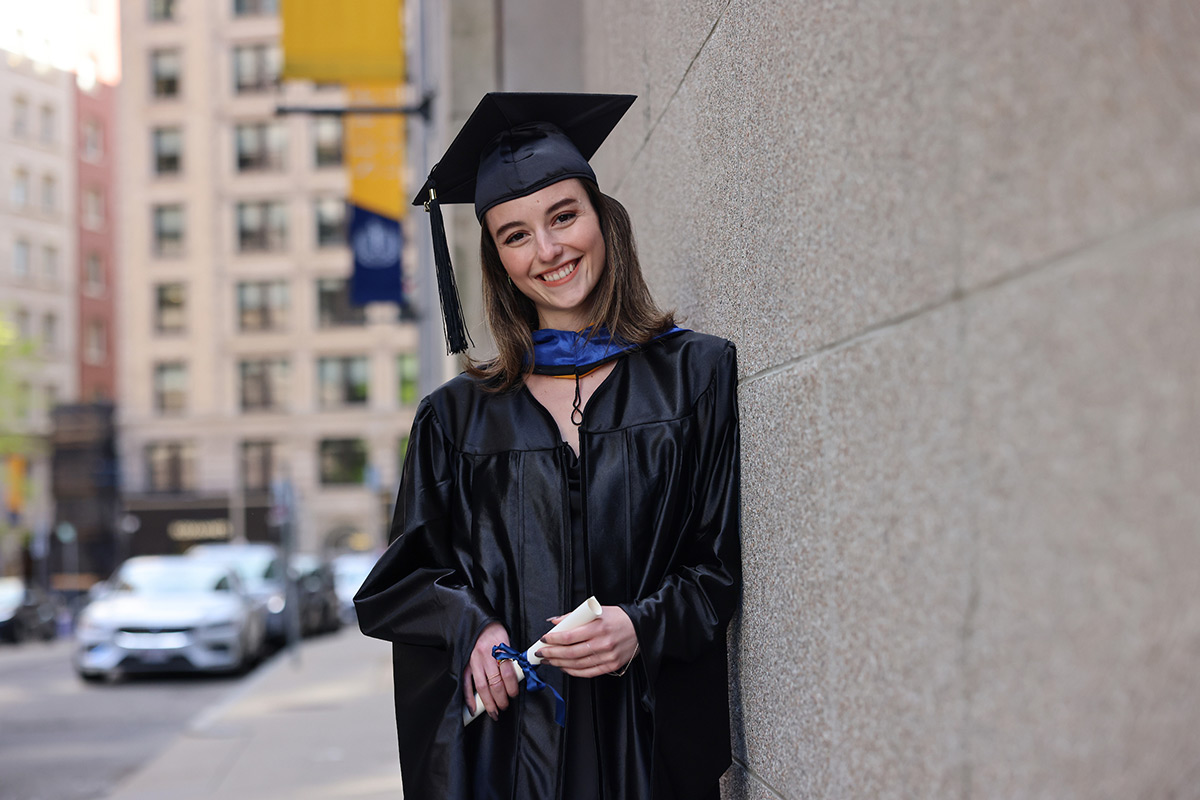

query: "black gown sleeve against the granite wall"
xmin=622 ymin=344 xmax=742 ymax=685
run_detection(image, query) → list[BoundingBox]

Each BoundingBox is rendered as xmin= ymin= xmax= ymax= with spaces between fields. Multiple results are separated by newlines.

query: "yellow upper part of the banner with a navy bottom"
xmin=344 ymin=85 xmax=408 ymax=219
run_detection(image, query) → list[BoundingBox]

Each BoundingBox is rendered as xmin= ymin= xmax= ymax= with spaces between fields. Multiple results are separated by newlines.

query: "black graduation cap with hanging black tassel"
xmin=413 ymin=92 xmax=636 ymax=353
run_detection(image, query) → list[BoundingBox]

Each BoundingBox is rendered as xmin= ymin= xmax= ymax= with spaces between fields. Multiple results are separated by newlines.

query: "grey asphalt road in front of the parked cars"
xmin=0 ymin=639 xmax=258 ymax=800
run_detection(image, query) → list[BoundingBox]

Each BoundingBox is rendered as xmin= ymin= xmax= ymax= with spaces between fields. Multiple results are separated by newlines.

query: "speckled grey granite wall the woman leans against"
xmin=583 ymin=0 xmax=1200 ymax=800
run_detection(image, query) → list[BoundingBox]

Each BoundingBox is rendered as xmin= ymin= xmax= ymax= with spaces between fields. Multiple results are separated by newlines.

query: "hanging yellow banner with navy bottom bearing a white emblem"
xmin=346 ymin=86 xmax=408 ymax=306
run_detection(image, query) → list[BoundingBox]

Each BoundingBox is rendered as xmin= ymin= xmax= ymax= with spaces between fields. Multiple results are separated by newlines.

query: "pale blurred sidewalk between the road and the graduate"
xmin=108 ymin=626 xmax=402 ymax=800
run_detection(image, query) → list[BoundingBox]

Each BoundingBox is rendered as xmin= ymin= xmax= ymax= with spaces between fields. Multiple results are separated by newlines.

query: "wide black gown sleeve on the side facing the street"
xmin=354 ymin=398 xmax=498 ymax=675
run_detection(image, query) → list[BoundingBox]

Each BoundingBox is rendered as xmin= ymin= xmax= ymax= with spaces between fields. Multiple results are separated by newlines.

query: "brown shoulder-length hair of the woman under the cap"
xmin=467 ymin=179 xmax=674 ymax=391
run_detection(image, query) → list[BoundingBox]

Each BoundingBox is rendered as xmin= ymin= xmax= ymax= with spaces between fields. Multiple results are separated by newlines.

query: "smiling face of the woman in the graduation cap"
xmin=484 ymin=179 xmax=605 ymax=331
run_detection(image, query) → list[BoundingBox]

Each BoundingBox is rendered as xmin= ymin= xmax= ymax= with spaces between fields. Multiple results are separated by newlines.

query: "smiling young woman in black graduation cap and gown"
xmin=355 ymin=94 xmax=740 ymax=800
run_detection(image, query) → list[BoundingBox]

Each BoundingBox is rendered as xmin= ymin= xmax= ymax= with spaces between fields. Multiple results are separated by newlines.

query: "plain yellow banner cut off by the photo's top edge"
xmin=280 ymin=0 xmax=404 ymax=83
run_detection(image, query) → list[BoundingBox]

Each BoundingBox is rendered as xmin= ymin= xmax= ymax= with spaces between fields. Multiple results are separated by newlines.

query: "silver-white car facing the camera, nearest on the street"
xmin=74 ymin=555 xmax=266 ymax=680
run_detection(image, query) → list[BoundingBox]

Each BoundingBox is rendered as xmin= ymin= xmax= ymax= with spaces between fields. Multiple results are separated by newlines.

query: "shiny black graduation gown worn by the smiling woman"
xmin=354 ymin=331 xmax=740 ymax=800
